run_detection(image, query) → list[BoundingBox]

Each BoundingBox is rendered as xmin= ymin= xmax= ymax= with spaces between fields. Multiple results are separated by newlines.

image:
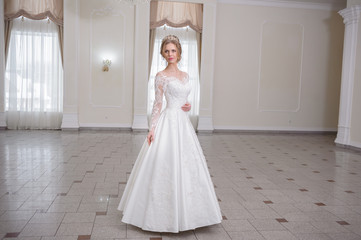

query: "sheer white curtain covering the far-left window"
xmin=5 ymin=17 xmax=63 ymax=129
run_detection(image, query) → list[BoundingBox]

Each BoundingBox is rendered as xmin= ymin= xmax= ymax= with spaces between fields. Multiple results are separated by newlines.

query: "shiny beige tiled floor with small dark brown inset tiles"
xmin=0 ymin=131 xmax=361 ymax=240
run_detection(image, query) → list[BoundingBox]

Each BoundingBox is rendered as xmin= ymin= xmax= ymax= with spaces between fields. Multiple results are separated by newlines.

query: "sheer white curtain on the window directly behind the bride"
xmin=148 ymin=25 xmax=199 ymax=129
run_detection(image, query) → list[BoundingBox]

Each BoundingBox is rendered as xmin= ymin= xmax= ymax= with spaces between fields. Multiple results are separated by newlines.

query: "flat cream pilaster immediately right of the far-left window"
xmin=61 ymin=0 xmax=79 ymax=130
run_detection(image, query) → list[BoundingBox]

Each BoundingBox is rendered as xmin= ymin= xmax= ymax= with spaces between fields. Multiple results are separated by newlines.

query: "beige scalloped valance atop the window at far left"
xmin=4 ymin=0 xmax=64 ymax=26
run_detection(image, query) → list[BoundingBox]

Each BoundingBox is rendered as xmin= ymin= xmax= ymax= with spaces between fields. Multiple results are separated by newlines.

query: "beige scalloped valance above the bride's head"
xmin=150 ymin=1 xmax=203 ymax=33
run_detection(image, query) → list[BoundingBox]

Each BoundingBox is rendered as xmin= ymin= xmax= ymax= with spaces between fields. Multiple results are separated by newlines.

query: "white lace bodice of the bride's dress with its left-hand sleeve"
xmin=150 ymin=73 xmax=191 ymax=130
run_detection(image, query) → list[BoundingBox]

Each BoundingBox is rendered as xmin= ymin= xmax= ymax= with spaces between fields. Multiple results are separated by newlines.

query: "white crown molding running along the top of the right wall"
xmin=218 ymin=0 xmax=346 ymax=11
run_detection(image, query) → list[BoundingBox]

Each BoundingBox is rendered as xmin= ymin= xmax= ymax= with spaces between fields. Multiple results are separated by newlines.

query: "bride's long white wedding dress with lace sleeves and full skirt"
xmin=118 ymin=73 xmax=222 ymax=232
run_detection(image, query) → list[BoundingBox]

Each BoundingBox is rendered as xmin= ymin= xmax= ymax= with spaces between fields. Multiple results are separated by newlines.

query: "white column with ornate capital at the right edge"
xmin=335 ymin=5 xmax=361 ymax=145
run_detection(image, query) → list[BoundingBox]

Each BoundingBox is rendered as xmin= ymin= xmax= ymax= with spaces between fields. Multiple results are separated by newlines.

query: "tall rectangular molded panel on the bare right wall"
xmin=258 ymin=22 xmax=303 ymax=112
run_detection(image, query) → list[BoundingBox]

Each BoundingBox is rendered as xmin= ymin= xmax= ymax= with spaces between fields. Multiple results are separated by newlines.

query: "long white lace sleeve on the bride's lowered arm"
xmin=149 ymin=75 xmax=164 ymax=131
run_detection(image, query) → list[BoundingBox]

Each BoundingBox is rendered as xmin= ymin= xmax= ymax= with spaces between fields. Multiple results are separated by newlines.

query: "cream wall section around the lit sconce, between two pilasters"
xmin=78 ymin=0 xmax=134 ymax=127
